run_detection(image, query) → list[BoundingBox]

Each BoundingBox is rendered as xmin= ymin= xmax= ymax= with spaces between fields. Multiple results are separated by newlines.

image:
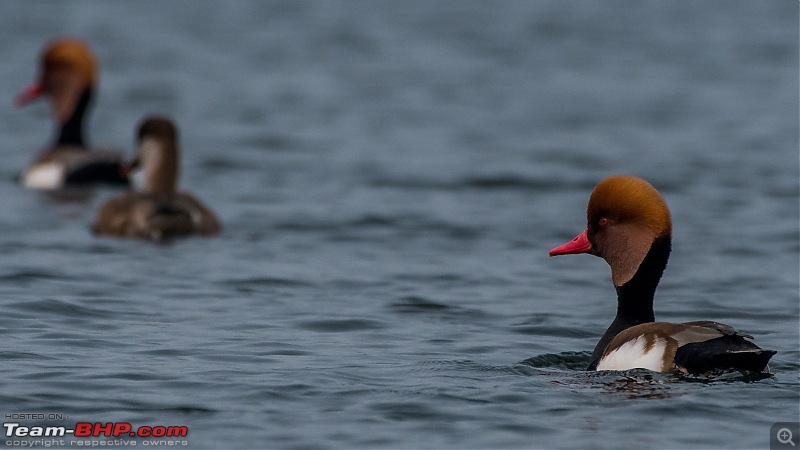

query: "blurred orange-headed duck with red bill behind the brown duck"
xmin=14 ymin=37 xmax=128 ymax=190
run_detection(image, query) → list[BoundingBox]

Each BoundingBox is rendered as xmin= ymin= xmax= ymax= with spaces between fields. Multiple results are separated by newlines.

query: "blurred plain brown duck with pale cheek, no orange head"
xmin=92 ymin=116 xmax=220 ymax=241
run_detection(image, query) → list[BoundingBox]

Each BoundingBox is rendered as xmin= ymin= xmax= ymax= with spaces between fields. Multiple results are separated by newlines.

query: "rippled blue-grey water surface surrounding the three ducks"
xmin=0 ymin=0 xmax=800 ymax=448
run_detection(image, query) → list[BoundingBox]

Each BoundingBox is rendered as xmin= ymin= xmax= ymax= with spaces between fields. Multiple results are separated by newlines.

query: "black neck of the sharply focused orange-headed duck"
xmin=588 ymin=236 xmax=672 ymax=370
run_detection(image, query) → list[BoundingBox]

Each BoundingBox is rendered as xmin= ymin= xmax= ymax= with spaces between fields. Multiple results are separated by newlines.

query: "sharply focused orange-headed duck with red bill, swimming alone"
xmin=549 ymin=175 xmax=777 ymax=375
